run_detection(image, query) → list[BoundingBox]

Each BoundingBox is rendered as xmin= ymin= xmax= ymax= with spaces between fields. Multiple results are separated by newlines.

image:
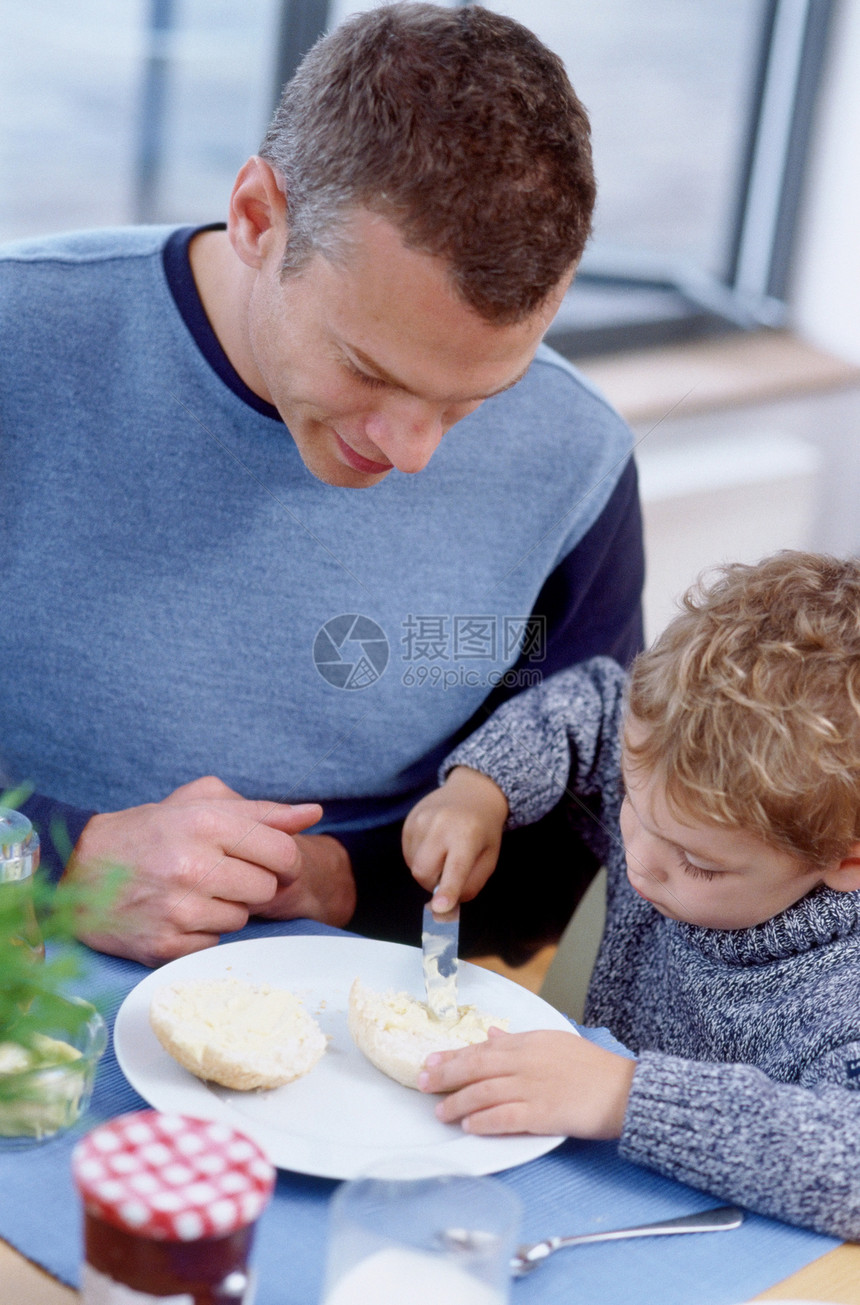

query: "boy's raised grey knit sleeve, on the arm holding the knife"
xmin=440 ymin=658 xmax=625 ymax=829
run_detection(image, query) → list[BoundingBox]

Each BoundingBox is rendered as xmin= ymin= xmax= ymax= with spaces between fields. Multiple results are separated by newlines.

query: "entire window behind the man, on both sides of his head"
xmin=0 ymin=0 xmax=834 ymax=355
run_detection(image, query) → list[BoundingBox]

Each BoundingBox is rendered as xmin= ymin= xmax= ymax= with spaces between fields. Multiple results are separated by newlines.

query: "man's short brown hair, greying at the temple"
xmin=260 ymin=4 xmax=595 ymax=324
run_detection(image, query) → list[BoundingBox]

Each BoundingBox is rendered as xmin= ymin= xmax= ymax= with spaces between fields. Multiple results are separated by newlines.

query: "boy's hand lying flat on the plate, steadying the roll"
xmin=418 ymin=1028 xmax=636 ymax=1138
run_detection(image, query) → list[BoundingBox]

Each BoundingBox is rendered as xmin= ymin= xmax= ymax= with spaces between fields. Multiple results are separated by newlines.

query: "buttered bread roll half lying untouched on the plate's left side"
xmin=149 ymin=979 xmax=326 ymax=1091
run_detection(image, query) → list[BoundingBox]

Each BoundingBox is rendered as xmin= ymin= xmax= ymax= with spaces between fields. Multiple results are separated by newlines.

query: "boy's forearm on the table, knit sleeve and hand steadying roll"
xmin=419 ymin=1031 xmax=860 ymax=1241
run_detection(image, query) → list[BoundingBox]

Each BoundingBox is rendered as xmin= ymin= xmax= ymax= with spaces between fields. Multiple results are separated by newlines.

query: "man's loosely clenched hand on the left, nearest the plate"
xmin=64 ymin=775 xmax=339 ymax=966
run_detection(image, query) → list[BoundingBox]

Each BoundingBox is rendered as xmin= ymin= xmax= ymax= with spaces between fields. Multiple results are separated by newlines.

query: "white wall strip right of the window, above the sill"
xmin=791 ymin=0 xmax=860 ymax=364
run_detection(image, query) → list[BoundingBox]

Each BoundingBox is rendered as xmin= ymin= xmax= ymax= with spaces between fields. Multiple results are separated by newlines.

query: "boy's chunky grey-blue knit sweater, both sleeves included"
xmin=441 ymin=658 xmax=860 ymax=1240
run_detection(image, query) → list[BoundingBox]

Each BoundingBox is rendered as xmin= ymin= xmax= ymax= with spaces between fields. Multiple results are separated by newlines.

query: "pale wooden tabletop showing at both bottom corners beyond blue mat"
xmin=0 ymin=1241 xmax=860 ymax=1305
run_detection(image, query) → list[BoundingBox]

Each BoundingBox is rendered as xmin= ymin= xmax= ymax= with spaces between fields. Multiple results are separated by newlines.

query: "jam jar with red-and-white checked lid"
xmin=72 ymin=1111 xmax=274 ymax=1305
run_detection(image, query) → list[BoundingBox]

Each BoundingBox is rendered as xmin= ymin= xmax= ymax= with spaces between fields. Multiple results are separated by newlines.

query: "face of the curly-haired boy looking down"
xmin=621 ymin=722 xmax=822 ymax=929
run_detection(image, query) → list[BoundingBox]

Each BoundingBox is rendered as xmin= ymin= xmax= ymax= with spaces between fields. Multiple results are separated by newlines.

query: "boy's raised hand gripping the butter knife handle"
xmin=403 ymin=766 xmax=508 ymax=915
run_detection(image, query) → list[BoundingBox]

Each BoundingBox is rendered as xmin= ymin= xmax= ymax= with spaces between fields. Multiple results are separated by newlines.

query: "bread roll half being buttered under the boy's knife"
xmin=350 ymin=979 xmax=508 ymax=1087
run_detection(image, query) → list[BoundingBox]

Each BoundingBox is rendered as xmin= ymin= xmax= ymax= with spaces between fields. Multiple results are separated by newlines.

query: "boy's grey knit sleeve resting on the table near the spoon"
xmin=619 ymin=1043 xmax=860 ymax=1241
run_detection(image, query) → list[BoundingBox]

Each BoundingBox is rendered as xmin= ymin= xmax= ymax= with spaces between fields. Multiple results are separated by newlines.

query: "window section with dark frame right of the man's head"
xmin=469 ymin=0 xmax=833 ymax=355
